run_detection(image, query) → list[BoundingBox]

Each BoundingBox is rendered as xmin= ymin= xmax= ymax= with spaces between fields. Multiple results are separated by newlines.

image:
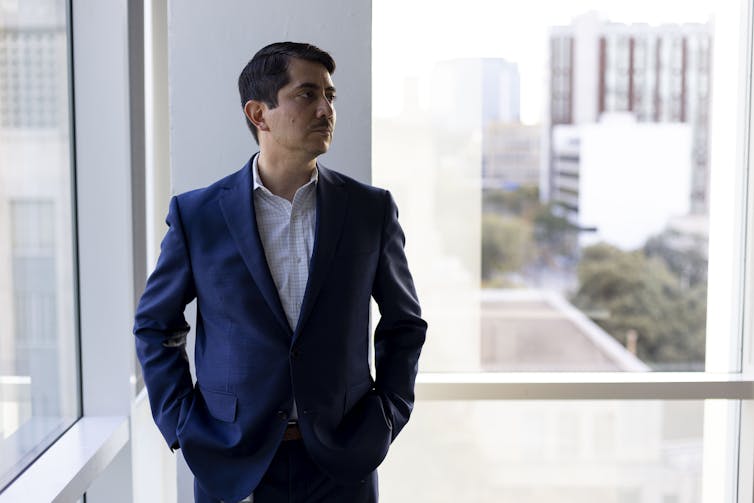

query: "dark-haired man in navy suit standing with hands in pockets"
xmin=134 ymin=42 xmax=427 ymax=503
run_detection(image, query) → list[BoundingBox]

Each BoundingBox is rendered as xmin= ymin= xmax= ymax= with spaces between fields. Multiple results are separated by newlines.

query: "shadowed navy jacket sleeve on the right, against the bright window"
xmin=372 ymin=192 xmax=427 ymax=438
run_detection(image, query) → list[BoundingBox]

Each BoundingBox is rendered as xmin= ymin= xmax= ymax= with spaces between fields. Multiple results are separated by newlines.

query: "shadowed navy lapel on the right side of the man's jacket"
xmin=293 ymin=165 xmax=348 ymax=340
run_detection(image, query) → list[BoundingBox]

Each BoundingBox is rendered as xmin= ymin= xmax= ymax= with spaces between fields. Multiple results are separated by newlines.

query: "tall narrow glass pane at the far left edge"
xmin=0 ymin=0 xmax=79 ymax=489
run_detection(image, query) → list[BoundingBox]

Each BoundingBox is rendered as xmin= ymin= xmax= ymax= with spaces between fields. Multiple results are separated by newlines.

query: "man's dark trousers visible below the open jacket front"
xmin=194 ymin=440 xmax=378 ymax=503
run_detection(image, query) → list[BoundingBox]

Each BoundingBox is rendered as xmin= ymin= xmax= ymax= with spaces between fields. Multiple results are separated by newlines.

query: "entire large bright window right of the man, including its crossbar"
xmin=373 ymin=0 xmax=752 ymax=503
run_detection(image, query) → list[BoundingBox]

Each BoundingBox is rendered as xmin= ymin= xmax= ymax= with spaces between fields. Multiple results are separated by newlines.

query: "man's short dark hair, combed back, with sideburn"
xmin=238 ymin=42 xmax=335 ymax=143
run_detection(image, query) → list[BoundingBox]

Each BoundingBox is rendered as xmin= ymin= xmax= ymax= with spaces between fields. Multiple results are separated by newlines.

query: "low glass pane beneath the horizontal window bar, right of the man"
xmin=380 ymin=400 xmax=737 ymax=503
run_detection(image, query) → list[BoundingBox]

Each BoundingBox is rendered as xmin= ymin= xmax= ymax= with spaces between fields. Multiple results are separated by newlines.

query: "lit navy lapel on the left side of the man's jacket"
xmin=220 ymin=161 xmax=291 ymax=334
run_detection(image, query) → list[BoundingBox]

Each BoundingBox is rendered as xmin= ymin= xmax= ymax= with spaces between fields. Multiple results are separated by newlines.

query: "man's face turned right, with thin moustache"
xmin=264 ymin=58 xmax=335 ymax=159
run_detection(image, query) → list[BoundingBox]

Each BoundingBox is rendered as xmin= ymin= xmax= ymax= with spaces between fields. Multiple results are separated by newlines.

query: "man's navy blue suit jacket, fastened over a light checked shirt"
xmin=134 ymin=158 xmax=427 ymax=501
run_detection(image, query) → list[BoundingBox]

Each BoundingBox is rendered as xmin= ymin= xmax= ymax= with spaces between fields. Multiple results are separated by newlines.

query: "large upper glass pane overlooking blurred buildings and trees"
xmin=373 ymin=0 xmax=744 ymax=371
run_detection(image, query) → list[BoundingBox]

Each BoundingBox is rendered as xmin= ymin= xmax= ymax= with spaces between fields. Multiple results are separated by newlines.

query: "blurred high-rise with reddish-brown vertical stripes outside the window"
xmin=541 ymin=13 xmax=712 ymax=214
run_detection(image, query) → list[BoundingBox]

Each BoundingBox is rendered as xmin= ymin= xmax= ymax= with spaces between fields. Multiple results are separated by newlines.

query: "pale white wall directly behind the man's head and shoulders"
xmin=168 ymin=0 xmax=372 ymax=193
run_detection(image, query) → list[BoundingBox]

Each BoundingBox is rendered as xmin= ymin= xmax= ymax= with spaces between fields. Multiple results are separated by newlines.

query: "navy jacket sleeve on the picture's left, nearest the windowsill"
xmin=134 ymin=197 xmax=196 ymax=448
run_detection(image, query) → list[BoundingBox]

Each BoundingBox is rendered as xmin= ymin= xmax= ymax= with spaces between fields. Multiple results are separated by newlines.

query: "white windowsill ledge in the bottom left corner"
xmin=0 ymin=416 xmax=128 ymax=503
